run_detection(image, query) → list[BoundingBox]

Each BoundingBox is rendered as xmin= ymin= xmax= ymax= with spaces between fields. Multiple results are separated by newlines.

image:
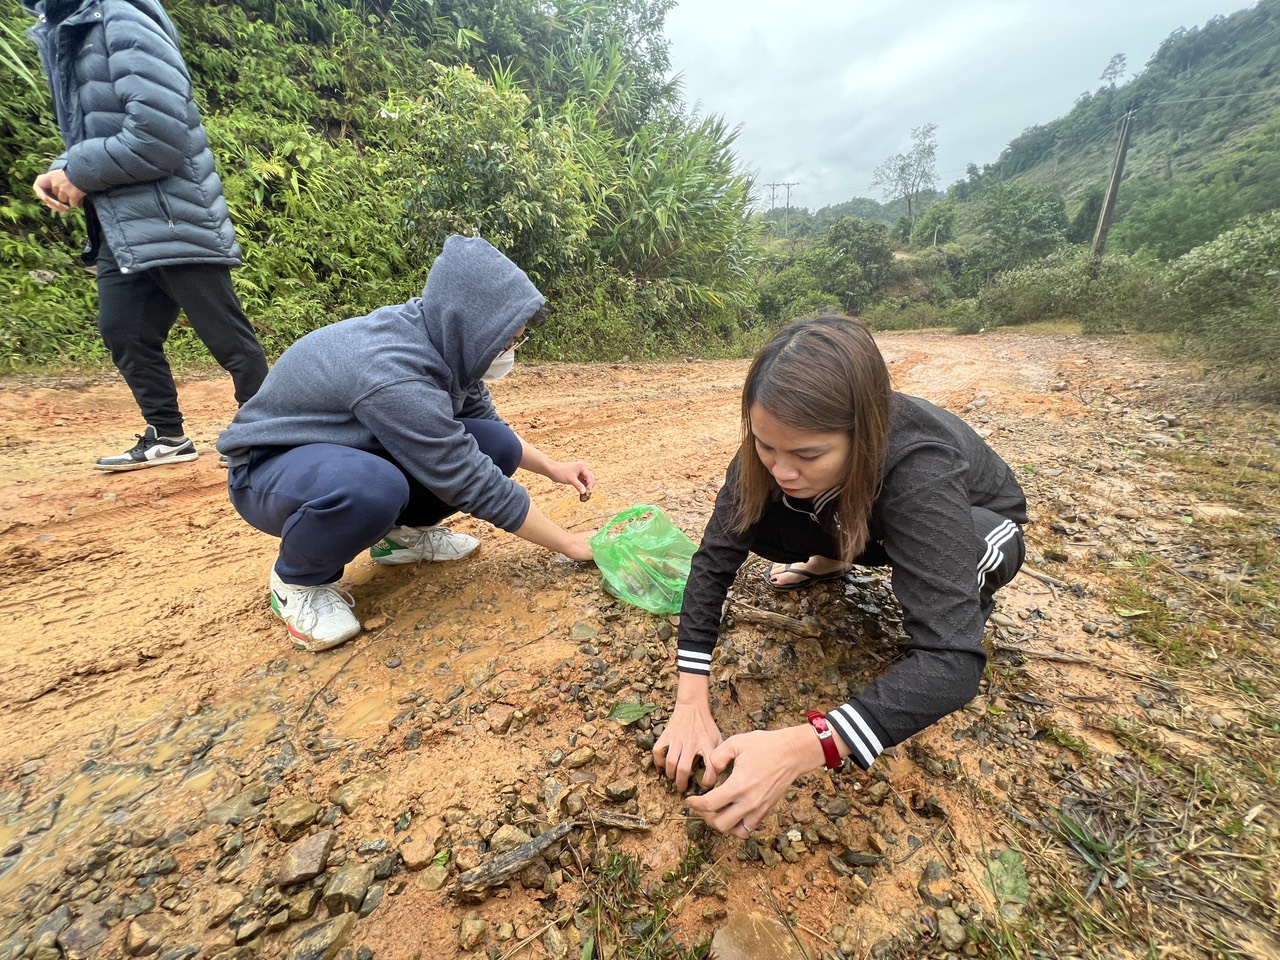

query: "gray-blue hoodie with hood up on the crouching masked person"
xmin=218 ymin=237 xmax=545 ymax=531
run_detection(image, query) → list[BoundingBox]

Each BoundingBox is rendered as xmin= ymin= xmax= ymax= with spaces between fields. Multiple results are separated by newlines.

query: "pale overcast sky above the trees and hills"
xmin=666 ymin=0 xmax=1252 ymax=210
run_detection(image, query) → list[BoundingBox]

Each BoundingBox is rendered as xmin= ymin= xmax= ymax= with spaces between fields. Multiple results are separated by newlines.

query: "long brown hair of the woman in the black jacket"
xmin=733 ymin=316 xmax=892 ymax=562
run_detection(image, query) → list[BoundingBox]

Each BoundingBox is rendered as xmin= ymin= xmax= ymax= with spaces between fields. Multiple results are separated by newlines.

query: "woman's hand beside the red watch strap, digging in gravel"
xmin=686 ymin=714 xmax=823 ymax=840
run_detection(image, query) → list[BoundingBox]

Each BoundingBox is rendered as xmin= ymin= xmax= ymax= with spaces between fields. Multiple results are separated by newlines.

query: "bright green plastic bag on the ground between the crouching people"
xmin=591 ymin=503 xmax=698 ymax=613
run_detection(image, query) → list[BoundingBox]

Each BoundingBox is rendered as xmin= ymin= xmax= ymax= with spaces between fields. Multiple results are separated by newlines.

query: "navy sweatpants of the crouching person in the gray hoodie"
xmin=227 ymin=420 xmax=522 ymax=586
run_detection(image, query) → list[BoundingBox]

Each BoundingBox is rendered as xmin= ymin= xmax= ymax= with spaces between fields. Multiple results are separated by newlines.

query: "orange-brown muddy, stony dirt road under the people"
xmin=0 ymin=333 xmax=1280 ymax=960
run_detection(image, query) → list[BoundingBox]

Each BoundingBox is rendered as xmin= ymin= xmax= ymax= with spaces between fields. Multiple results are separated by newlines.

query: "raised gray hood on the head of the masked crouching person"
xmin=421 ymin=236 xmax=547 ymax=385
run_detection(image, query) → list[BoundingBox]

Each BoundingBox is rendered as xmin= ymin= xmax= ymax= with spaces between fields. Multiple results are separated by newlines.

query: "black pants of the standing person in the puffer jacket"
xmin=97 ymin=243 xmax=266 ymax=436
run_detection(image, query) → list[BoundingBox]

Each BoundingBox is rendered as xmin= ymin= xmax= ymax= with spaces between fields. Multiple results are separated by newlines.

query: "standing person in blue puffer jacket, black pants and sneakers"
xmin=23 ymin=0 xmax=266 ymax=471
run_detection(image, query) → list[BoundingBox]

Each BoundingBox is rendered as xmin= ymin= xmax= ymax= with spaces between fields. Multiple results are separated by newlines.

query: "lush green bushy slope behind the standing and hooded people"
xmin=0 ymin=0 xmax=753 ymax=367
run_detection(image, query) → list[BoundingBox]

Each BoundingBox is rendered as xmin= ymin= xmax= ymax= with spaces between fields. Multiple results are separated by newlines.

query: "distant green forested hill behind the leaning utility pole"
xmin=954 ymin=0 xmax=1280 ymax=260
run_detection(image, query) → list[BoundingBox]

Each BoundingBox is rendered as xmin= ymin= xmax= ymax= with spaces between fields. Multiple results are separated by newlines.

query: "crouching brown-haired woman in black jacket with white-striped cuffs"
xmin=653 ymin=316 xmax=1027 ymax=837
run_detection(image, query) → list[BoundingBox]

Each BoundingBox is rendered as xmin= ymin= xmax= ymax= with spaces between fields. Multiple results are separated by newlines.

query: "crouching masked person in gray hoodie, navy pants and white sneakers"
xmin=218 ymin=237 xmax=595 ymax=650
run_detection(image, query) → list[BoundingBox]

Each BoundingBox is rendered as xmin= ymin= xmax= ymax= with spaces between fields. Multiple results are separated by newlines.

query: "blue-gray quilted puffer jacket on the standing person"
xmin=23 ymin=0 xmax=241 ymax=273
